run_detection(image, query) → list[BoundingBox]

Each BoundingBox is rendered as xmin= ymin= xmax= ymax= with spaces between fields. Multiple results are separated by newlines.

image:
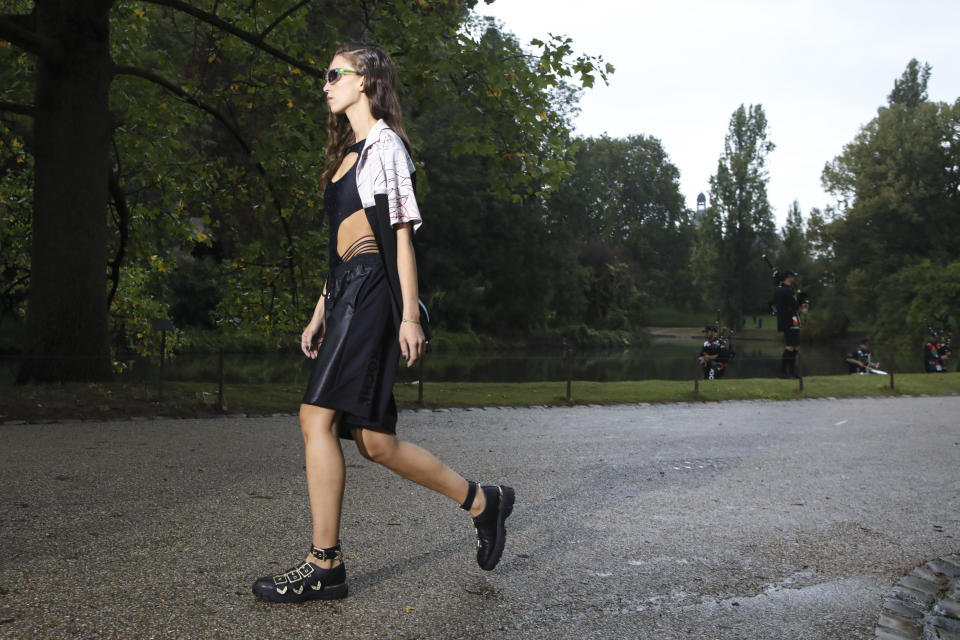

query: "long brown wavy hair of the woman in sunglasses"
xmin=321 ymin=42 xmax=410 ymax=188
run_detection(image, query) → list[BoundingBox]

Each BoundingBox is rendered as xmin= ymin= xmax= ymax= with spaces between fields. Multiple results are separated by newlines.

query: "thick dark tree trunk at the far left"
xmin=18 ymin=0 xmax=112 ymax=383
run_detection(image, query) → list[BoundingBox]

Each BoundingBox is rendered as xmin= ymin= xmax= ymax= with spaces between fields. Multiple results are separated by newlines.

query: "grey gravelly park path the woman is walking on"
xmin=0 ymin=396 xmax=960 ymax=640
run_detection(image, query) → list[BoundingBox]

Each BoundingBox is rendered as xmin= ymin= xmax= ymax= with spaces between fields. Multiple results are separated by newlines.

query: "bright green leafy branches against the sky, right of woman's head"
xmin=430 ymin=17 xmax=613 ymax=203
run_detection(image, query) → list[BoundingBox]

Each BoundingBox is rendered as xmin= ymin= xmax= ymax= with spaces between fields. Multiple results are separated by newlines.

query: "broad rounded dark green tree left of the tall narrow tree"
xmin=548 ymin=135 xmax=693 ymax=330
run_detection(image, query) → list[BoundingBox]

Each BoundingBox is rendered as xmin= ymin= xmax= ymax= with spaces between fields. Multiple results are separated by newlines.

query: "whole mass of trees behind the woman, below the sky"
xmin=0 ymin=12 xmax=960 ymax=380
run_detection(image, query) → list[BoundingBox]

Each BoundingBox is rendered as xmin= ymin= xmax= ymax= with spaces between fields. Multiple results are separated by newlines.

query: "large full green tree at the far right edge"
xmin=823 ymin=60 xmax=960 ymax=337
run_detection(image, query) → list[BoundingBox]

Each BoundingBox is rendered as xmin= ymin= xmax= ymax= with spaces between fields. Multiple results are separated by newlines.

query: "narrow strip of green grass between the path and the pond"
xmin=0 ymin=373 xmax=960 ymax=423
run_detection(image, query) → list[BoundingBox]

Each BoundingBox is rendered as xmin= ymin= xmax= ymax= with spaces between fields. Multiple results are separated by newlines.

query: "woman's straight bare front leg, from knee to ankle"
xmin=300 ymin=404 xmax=345 ymax=569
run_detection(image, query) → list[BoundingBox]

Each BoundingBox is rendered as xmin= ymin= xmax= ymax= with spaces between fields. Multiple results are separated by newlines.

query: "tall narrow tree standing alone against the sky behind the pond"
xmin=697 ymin=105 xmax=776 ymax=327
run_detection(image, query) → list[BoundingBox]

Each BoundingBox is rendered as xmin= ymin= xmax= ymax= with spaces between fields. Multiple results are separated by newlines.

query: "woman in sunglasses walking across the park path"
xmin=253 ymin=44 xmax=514 ymax=602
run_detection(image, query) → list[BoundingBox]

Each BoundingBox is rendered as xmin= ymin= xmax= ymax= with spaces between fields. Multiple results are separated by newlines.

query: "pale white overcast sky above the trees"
xmin=476 ymin=0 xmax=960 ymax=226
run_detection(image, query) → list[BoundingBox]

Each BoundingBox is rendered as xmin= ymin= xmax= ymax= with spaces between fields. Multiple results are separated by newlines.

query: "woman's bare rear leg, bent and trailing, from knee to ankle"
xmin=353 ymin=429 xmax=486 ymax=516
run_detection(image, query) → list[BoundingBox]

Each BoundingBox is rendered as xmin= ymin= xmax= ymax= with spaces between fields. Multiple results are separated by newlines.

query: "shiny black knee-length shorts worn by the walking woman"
xmin=303 ymin=253 xmax=400 ymax=439
